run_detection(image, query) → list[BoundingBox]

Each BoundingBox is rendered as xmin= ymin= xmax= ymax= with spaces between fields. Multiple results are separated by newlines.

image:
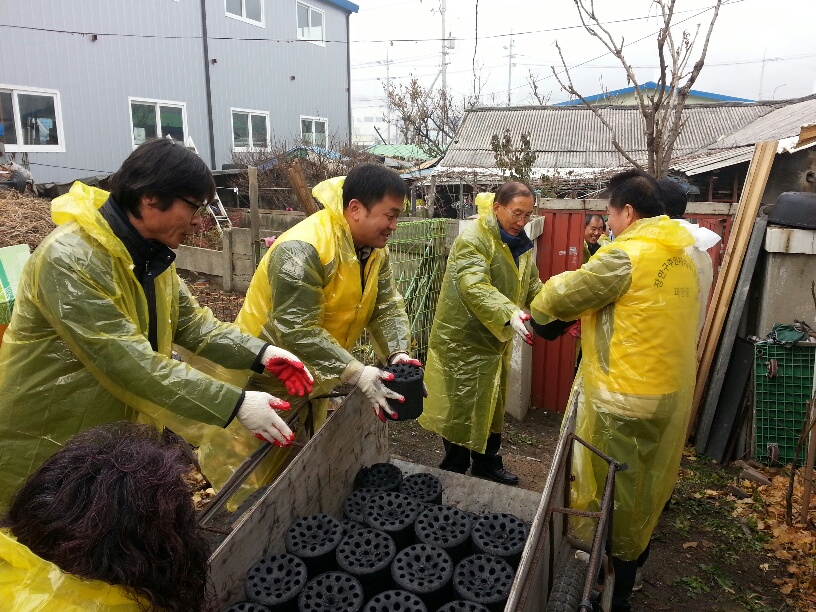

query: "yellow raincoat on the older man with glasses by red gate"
xmin=419 ymin=194 xmax=541 ymax=453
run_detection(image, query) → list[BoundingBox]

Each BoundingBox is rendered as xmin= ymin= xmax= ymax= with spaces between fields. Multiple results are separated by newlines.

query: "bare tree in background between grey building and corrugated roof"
xmin=385 ymin=78 xmax=473 ymax=157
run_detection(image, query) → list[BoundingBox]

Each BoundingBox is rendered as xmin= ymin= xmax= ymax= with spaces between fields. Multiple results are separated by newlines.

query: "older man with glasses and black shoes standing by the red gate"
xmin=419 ymin=182 xmax=541 ymax=484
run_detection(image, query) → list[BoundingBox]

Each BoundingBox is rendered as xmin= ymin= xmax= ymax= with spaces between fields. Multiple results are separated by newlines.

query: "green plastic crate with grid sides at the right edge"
xmin=754 ymin=342 xmax=816 ymax=465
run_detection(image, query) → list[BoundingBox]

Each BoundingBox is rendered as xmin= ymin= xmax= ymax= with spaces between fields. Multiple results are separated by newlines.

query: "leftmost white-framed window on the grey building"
xmin=0 ymin=85 xmax=65 ymax=153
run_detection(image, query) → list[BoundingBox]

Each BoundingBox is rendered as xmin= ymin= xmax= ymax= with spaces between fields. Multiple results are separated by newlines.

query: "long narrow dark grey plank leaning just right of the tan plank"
xmin=696 ymin=216 xmax=768 ymax=452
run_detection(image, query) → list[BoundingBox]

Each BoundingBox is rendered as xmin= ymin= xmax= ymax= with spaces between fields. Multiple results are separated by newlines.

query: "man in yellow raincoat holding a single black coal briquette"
xmin=235 ymin=164 xmax=420 ymax=460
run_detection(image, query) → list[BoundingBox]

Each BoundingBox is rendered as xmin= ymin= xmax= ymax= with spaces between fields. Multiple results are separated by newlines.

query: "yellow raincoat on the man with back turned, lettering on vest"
xmin=531 ymin=216 xmax=698 ymax=561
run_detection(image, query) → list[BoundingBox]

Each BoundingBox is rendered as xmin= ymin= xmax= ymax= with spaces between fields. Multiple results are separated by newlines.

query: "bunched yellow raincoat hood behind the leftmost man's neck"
xmin=51 ymin=181 xmax=132 ymax=263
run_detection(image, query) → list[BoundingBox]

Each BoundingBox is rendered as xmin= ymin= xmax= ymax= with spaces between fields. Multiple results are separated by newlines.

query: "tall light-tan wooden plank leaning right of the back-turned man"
xmin=688 ymin=140 xmax=777 ymax=434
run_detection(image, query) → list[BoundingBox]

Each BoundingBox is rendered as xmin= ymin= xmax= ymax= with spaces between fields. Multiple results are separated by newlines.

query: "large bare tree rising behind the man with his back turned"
xmin=552 ymin=0 xmax=722 ymax=178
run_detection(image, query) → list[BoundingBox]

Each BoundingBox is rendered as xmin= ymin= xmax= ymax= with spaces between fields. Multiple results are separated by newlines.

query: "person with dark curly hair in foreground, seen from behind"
xmin=0 ymin=421 xmax=213 ymax=612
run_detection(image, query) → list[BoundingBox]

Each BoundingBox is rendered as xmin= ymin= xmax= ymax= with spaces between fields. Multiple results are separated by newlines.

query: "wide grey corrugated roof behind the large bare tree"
xmin=440 ymin=103 xmax=778 ymax=168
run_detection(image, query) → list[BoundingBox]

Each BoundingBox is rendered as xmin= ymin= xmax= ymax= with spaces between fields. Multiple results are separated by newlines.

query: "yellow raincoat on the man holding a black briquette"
xmin=235 ymin=176 xmax=410 ymax=464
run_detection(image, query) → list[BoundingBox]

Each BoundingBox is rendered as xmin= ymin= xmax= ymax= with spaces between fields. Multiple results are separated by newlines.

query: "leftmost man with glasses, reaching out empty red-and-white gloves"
xmin=0 ymin=139 xmax=311 ymax=510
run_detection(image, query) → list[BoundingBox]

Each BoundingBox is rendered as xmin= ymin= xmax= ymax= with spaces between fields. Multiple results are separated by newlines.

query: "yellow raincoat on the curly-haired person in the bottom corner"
xmin=0 ymin=530 xmax=143 ymax=612
